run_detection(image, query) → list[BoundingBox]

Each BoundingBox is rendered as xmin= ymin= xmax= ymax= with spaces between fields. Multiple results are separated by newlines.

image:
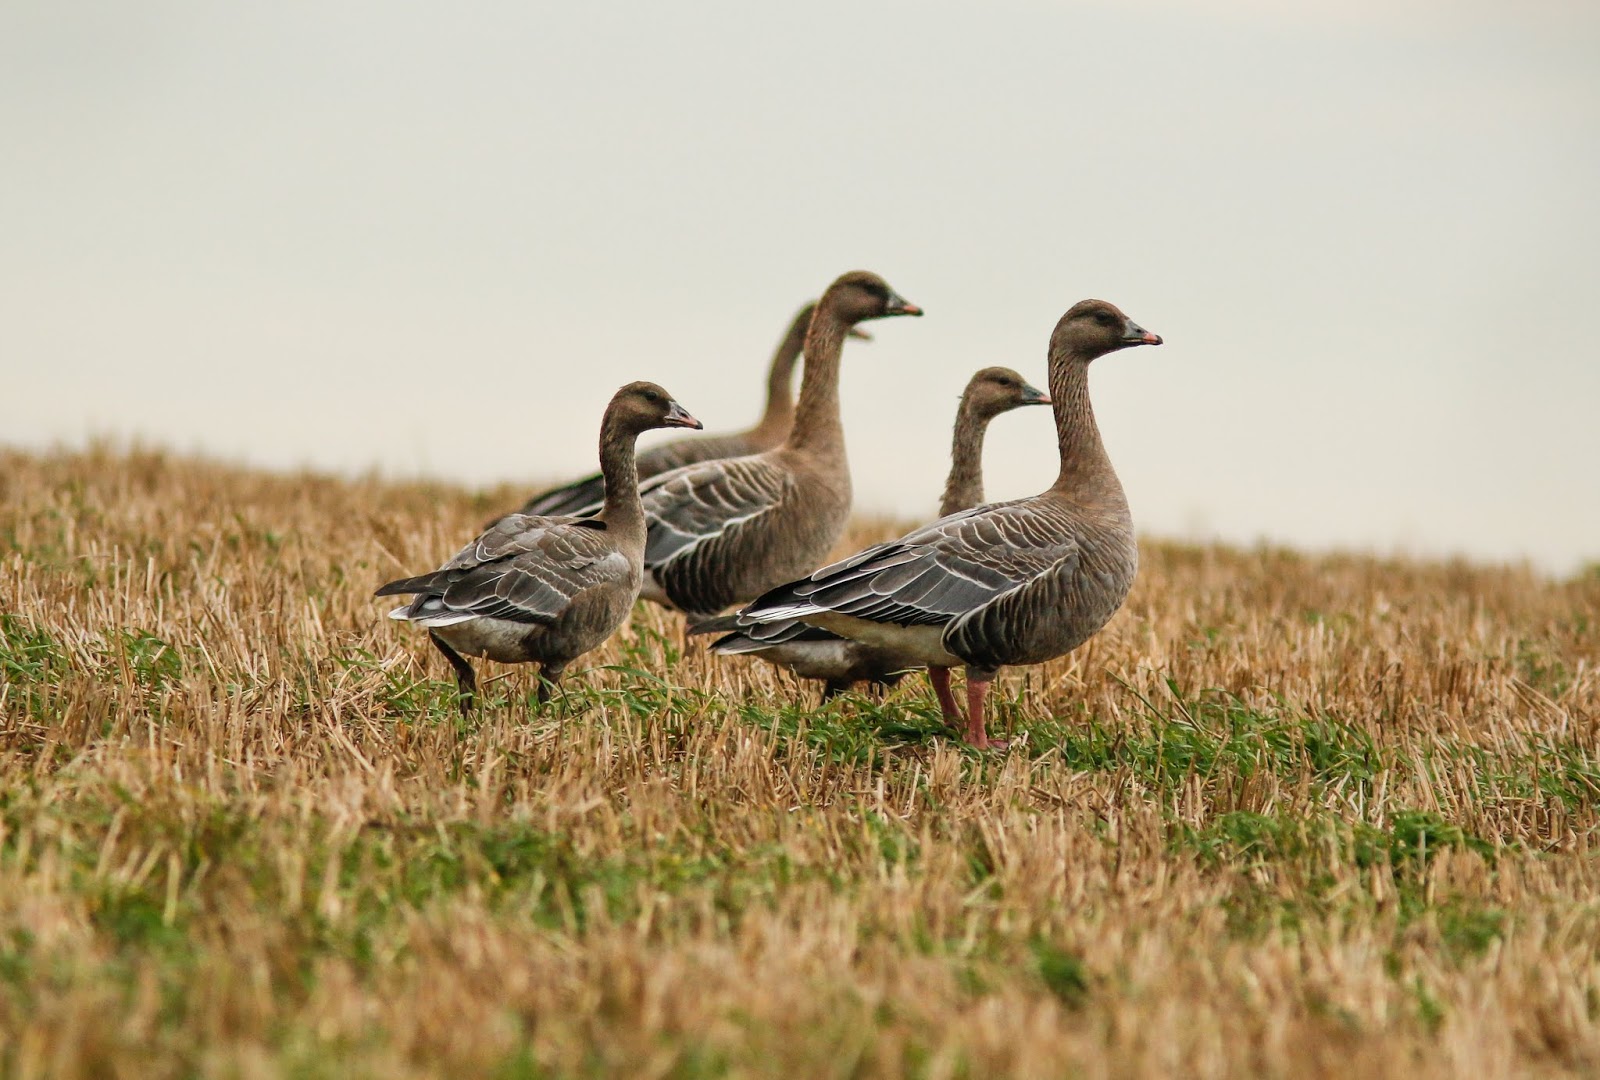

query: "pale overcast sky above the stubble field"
xmin=0 ymin=0 xmax=1600 ymax=573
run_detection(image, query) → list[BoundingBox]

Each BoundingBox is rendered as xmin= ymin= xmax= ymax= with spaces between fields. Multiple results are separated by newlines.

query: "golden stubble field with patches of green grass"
xmin=0 ymin=450 xmax=1600 ymax=1077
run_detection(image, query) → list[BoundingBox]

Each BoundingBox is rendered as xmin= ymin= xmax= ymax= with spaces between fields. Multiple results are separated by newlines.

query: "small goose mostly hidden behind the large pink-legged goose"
xmin=707 ymin=368 xmax=1050 ymax=701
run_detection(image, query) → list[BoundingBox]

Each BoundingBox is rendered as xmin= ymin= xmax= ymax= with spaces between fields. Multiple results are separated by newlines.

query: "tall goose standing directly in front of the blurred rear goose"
xmin=601 ymin=270 xmax=922 ymax=622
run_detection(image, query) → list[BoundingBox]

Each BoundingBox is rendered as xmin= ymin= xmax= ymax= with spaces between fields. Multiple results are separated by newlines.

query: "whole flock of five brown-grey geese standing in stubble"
xmin=378 ymin=270 xmax=1162 ymax=749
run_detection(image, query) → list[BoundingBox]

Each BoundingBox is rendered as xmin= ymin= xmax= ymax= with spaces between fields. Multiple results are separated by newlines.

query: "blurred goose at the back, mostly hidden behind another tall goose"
xmin=520 ymin=301 xmax=872 ymax=515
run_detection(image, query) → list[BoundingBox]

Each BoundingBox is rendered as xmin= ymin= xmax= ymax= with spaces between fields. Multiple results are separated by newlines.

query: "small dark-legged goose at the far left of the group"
xmin=376 ymin=382 xmax=701 ymax=712
